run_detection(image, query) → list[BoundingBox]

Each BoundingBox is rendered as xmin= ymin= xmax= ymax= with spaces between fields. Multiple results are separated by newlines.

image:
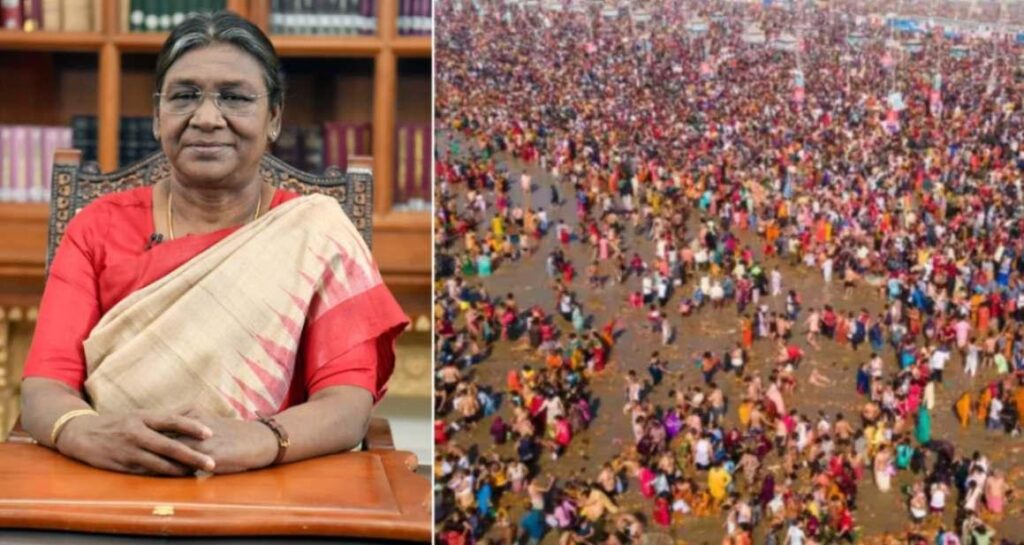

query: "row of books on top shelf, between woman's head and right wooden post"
xmin=270 ymin=0 xmax=377 ymax=36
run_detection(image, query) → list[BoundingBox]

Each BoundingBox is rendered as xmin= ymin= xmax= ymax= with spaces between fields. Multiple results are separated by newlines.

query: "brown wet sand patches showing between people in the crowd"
xmin=437 ymin=135 xmax=1024 ymax=544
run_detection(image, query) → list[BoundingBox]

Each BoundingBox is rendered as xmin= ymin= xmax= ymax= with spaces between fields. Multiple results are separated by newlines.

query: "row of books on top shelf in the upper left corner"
xmin=0 ymin=0 xmax=102 ymax=32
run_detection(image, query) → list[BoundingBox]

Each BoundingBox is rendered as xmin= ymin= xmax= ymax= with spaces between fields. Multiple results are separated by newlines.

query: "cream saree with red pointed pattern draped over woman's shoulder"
xmin=84 ymin=196 xmax=408 ymax=419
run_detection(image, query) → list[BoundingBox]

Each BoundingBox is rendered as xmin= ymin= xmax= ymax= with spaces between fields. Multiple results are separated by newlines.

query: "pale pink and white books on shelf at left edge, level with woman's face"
xmin=0 ymin=125 xmax=72 ymax=203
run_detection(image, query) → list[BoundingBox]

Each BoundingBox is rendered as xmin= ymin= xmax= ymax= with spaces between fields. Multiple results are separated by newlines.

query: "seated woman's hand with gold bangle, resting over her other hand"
xmin=56 ymin=412 xmax=217 ymax=476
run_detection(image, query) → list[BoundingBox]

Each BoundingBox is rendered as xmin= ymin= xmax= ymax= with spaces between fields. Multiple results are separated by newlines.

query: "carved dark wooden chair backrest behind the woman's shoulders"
xmin=46 ymin=150 xmax=374 ymax=274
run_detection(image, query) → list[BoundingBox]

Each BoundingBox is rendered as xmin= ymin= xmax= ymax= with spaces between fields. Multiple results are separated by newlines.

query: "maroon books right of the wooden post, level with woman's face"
xmin=394 ymin=123 xmax=425 ymax=208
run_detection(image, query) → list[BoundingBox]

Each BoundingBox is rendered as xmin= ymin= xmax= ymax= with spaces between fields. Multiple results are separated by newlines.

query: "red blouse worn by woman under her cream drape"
xmin=24 ymin=186 xmax=404 ymax=410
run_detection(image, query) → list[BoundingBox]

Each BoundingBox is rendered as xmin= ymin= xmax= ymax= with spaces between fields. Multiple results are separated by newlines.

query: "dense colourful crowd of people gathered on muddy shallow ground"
xmin=434 ymin=0 xmax=1024 ymax=545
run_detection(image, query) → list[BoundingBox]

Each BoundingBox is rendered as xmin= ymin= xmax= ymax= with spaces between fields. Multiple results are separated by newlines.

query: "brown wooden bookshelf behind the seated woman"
xmin=0 ymin=0 xmax=432 ymax=430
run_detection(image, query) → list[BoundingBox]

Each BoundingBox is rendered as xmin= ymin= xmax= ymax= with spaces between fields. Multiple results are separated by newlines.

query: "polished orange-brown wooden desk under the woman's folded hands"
xmin=0 ymin=444 xmax=431 ymax=542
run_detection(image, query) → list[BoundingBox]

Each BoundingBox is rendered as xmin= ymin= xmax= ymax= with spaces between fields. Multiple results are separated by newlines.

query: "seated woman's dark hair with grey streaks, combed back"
xmin=157 ymin=11 xmax=285 ymax=107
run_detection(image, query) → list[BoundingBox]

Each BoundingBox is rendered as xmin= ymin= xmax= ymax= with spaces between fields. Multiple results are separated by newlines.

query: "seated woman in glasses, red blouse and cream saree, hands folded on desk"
xmin=22 ymin=12 xmax=408 ymax=475
